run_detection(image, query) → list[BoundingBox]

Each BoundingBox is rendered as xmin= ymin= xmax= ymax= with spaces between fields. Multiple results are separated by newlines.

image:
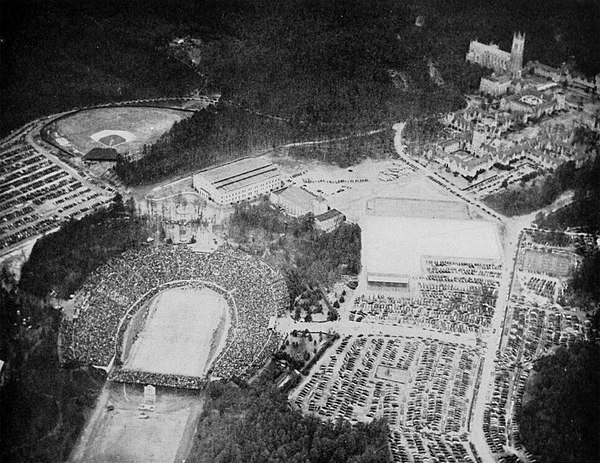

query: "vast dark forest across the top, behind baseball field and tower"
xmin=0 ymin=0 xmax=600 ymax=134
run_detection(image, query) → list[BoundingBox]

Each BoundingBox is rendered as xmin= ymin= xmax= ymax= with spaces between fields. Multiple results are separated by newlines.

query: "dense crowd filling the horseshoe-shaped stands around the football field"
xmin=61 ymin=245 xmax=288 ymax=384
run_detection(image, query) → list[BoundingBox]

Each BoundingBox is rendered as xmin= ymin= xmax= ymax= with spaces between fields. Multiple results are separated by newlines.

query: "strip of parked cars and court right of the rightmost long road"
xmin=483 ymin=230 xmax=590 ymax=463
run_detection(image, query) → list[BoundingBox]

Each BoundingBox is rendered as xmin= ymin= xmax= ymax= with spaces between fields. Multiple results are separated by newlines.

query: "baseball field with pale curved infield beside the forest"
xmin=50 ymin=106 xmax=192 ymax=157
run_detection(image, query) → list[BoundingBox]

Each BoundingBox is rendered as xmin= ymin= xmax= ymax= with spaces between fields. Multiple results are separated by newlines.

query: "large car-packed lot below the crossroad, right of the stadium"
xmin=291 ymin=335 xmax=481 ymax=462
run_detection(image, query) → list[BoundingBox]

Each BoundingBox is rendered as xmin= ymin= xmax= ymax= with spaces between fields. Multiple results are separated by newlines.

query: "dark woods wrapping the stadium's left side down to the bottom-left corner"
xmin=0 ymin=196 xmax=148 ymax=463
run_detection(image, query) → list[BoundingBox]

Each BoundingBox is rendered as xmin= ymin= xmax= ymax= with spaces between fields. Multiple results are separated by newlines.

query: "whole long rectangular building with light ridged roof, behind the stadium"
xmin=192 ymin=158 xmax=283 ymax=204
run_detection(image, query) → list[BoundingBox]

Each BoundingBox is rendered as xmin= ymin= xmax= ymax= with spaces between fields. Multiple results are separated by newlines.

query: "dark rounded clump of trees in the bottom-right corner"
xmin=517 ymin=342 xmax=600 ymax=463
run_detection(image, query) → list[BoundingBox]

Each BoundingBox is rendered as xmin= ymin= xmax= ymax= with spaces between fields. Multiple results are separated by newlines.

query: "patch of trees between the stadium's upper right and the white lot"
xmin=229 ymin=200 xmax=361 ymax=301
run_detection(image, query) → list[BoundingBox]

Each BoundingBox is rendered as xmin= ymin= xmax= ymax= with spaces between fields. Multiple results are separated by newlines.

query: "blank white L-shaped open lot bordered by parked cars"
xmin=362 ymin=215 xmax=502 ymax=275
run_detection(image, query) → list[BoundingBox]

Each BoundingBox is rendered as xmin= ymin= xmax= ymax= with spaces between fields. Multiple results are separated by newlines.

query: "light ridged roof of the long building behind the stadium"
xmin=200 ymin=158 xmax=279 ymax=191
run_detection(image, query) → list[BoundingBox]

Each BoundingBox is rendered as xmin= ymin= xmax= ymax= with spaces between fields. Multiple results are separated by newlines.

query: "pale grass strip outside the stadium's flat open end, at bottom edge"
xmin=70 ymin=382 xmax=203 ymax=463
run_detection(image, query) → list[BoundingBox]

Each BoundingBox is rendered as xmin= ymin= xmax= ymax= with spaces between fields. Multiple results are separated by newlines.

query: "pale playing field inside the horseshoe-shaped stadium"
xmin=125 ymin=287 xmax=228 ymax=376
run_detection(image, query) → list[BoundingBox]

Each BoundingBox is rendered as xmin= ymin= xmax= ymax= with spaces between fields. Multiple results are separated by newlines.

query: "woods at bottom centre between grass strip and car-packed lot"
xmin=187 ymin=383 xmax=392 ymax=463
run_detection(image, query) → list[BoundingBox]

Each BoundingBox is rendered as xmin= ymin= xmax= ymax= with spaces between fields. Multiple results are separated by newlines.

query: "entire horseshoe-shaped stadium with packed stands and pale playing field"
xmin=60 ymin=246 xmax=288 ymax=389
